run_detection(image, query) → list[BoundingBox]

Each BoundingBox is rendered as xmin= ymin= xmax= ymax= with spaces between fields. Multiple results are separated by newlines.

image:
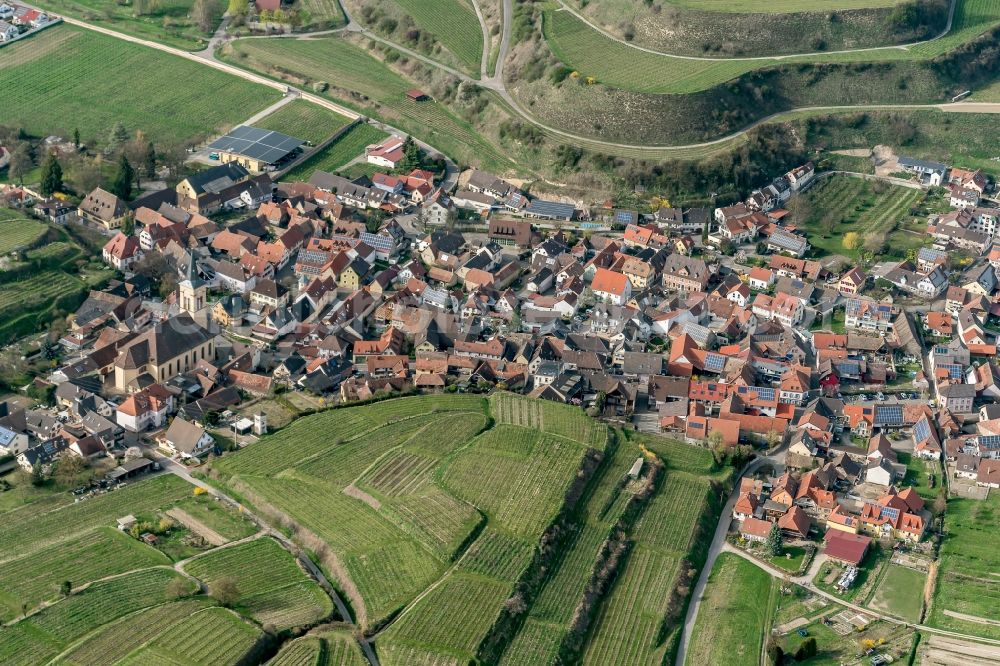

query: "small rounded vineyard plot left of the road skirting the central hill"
xmin=184 ymin=537 xmax=333 ymax=631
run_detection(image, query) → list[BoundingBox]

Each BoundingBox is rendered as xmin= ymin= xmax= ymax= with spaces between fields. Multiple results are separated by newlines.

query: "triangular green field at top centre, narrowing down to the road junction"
xmin=394 ymin=0 xmax=483 ymax=77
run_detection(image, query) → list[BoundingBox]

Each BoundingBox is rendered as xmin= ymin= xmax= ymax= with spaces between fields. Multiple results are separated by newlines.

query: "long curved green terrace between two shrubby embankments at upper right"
xmin=544 ymin=0 xmax=1000 ymax=94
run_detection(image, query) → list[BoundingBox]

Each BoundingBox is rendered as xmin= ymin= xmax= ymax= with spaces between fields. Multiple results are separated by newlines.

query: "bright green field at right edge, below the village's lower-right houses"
xmin=926 ymin=492 xmax=1000 ymax=638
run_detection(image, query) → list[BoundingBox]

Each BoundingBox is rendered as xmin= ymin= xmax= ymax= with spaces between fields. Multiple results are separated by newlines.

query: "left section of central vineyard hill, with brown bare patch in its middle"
xmin=216 ymin=396 xmax=494 ymax=625
